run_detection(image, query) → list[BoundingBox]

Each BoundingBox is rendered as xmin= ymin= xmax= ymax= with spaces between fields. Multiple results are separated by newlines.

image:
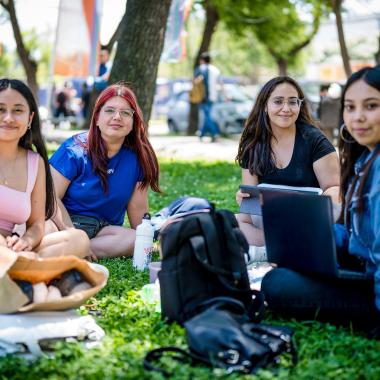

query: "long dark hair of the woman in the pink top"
xmin=0 ymin=78 xmax=55 ymax=219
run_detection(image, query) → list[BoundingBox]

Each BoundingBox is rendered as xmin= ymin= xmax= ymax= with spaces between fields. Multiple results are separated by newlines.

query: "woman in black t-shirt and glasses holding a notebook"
xmin=236 ymin=76 xmax=339 ymax=246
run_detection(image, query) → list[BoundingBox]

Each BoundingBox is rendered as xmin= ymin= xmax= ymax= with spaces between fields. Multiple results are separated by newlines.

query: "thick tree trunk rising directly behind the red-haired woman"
xmin=110 ymin=0 xmax=171 ymax=124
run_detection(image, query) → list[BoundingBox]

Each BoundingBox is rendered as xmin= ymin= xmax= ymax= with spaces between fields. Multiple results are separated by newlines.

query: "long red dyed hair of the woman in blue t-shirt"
xmin=86 ymin=82 xmax=161 ymax=192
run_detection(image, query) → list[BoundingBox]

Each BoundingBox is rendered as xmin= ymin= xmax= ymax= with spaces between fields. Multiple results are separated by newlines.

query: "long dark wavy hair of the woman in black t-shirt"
xmin=236 ymin=76 xmax=313 ymax=176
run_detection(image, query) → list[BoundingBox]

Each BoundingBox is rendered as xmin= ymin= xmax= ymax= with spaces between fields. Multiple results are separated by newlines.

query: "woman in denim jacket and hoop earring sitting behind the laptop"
xmin=262 ymin=66 xmax=380 ymax=339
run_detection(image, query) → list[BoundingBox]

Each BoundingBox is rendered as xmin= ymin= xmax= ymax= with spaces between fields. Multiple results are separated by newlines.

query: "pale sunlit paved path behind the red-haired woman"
xmin=42 ymin=124 xmax=239 ymax=161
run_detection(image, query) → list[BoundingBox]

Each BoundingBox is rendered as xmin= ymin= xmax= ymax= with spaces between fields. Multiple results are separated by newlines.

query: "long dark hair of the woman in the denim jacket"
xmin=338 ymin=66 xmax=380 ymax=222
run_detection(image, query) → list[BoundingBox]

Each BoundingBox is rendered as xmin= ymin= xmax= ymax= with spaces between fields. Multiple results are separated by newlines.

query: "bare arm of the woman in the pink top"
xmin=7 ymin=157 xmax=46 ymax=252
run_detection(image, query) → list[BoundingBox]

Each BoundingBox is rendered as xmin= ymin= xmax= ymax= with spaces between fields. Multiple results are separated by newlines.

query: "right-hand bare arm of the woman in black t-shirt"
xmin=313 ymin=152 xmax=341 ymax=203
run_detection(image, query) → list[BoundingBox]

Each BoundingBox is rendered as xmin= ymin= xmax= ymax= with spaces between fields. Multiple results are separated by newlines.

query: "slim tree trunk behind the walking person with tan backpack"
xmin=187 ymin=0 xmax=219 ymax=136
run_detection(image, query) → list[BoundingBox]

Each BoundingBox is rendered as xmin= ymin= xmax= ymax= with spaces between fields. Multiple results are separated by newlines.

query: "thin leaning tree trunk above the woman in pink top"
xmin=0 ymin=0 xmax=38 ymax=101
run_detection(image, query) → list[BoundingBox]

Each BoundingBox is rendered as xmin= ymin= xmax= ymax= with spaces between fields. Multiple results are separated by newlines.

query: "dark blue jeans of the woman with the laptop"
xmin=261 ymin=268 xmax=380 ymax=328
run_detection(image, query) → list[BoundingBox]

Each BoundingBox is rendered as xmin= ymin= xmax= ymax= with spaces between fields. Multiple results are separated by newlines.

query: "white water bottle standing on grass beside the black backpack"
xmin=133 ymin=213 xmax=154 ymax=270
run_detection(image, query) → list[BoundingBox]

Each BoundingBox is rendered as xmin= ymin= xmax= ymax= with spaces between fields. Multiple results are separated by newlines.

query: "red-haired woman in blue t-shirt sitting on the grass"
xmin=50 ymin=83 xmax=160 ymax=257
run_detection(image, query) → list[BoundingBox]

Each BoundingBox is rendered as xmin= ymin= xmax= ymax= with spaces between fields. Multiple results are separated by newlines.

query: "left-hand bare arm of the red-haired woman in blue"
xmin=50 ymin=165 xmax=74 ymax=231
